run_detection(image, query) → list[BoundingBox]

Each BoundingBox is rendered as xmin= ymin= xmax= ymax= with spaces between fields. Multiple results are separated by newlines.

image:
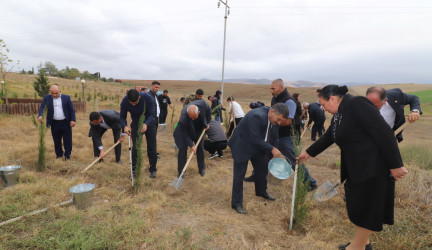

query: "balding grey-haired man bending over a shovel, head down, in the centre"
xmin=174 ymin=100 xmax=211 ymax=176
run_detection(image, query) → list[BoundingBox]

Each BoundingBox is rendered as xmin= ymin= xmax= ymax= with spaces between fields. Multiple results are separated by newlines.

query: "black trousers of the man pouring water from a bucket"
xmin=231 ymin=153 xmax=270 ymax=206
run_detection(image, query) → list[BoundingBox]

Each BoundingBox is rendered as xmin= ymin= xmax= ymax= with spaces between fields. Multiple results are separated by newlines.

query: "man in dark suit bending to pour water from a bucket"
xmin=228 ymin=103 xmax=289 ymax=214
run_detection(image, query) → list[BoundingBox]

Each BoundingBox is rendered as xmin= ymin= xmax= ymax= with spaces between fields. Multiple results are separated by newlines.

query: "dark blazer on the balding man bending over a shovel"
xmin=174 ymin=100 xmax=211 ymax=148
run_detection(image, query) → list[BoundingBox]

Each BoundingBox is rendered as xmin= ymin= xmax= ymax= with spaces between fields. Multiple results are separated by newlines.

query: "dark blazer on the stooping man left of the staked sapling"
xmin=89 ymin=110 xmax=122 ymax=147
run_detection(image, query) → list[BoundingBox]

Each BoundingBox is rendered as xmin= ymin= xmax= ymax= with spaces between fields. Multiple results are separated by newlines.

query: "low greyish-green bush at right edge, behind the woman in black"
xmin=400 ymin=145 xmax=432 ymax=170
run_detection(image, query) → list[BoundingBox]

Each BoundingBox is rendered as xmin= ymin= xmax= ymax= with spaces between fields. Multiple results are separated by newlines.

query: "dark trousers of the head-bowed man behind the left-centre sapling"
xmin=131 ymin=123 xmax=157 ymax=173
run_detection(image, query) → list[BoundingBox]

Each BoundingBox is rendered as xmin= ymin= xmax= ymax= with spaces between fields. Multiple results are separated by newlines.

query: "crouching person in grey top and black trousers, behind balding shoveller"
xmin=204 ymin=120 xmax=227 ymax=159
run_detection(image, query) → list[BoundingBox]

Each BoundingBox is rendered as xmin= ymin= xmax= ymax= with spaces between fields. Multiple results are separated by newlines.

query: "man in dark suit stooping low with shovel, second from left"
xmin=89 ymin=110 xmax=124 ymax=165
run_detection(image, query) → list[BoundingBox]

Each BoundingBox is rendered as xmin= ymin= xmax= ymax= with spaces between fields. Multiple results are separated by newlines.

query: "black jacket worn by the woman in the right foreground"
xmin=306 ymin=95 xmax=403 ymax=183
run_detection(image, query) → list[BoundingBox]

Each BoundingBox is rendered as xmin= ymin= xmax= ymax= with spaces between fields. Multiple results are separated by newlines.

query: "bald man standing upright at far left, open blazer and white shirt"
xmin=38 ymin=84 xmax=76 ymax=160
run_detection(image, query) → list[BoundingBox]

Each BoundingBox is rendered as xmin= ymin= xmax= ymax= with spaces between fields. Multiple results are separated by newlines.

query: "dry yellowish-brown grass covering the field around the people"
xmin=0 ymin=77 xmax=432 ymax=249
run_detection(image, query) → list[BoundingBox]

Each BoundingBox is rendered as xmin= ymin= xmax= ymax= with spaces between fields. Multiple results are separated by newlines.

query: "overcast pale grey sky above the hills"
xmin=0 ymin=0 xmax=432 ymax=83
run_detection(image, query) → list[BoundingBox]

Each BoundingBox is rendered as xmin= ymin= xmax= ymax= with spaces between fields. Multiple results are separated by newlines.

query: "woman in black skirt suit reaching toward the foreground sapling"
xmin=298 ymin=85 xmax=408 ymax=249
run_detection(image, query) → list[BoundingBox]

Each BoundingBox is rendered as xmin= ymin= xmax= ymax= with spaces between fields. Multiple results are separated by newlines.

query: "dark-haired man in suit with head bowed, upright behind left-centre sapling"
xmin=120 ymin=89 xmax=157 ymax=178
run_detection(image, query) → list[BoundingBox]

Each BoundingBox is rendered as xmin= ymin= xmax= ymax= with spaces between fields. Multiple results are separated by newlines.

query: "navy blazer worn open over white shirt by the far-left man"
xmin=38 ymin=94 xmax=76 ymax=127
